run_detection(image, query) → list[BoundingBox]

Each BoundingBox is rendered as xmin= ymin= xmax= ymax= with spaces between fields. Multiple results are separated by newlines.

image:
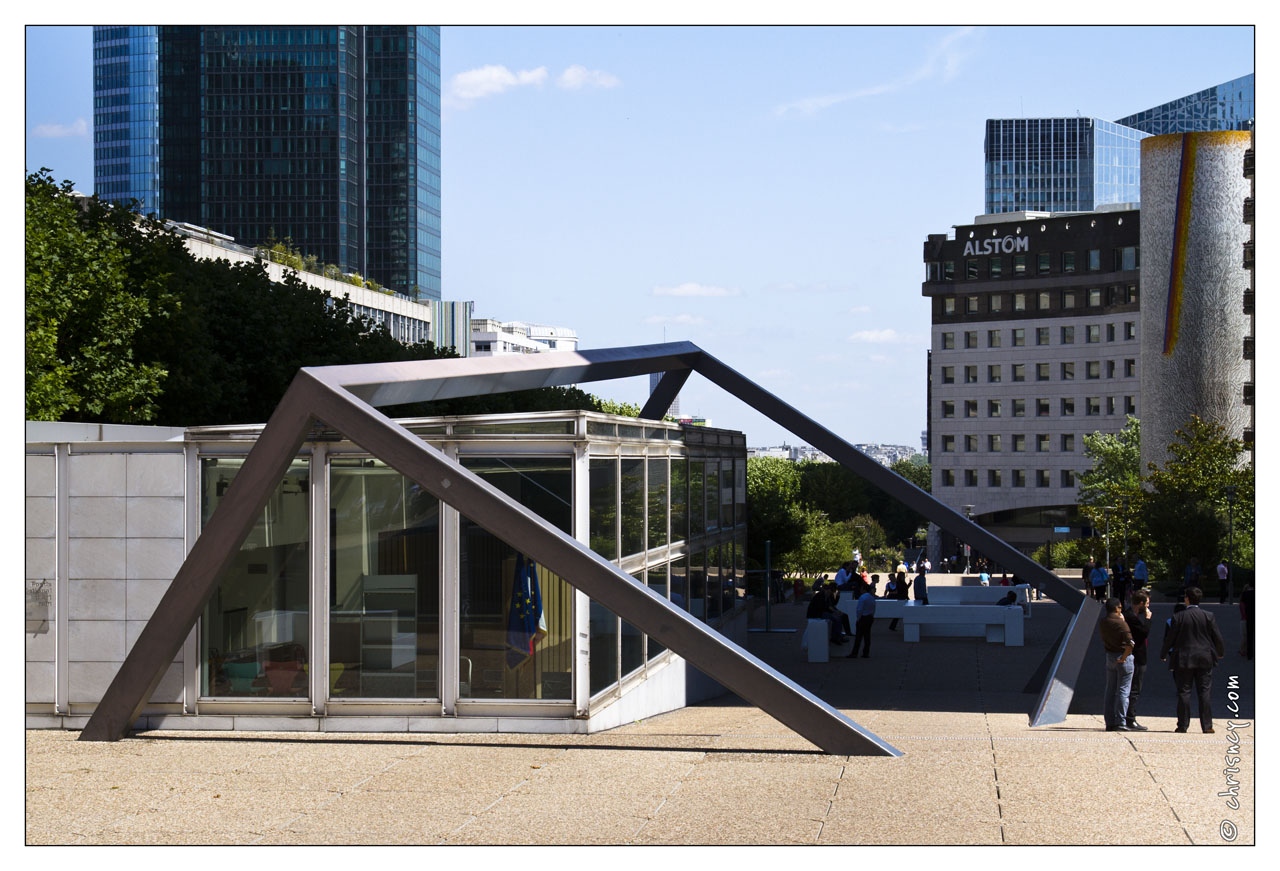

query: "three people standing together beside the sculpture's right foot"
xmin=1098 ymin=587 xmax=1226 ymax=734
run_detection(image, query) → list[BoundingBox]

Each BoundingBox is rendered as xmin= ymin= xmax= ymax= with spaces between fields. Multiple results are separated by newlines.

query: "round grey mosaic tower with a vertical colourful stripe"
xmin=1138 ymin=131 xmax=1249 ymax=471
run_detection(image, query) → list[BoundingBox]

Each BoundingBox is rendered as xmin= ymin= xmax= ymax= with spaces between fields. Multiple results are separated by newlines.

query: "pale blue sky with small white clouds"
xmin=26 ymin=27 xmax=1253 ymax=447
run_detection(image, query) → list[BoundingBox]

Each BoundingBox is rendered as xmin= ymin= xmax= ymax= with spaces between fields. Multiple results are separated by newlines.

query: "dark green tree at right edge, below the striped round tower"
xmin=1143 ymin=415 xmax=1253 ymax=576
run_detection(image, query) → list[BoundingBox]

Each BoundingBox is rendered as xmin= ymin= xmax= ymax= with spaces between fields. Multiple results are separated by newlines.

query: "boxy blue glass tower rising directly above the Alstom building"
xmin=984 ymin=118 xmax=1148 ymax=214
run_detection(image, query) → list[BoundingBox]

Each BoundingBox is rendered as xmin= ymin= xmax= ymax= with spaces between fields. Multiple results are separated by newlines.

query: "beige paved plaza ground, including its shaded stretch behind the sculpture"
xmin=26 ymin=578 xmax=1254 ymax=845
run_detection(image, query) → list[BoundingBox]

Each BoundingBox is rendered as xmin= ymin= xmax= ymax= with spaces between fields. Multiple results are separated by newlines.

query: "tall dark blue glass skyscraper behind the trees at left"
xmin=93 ymin=26 xmax=440 ymax=300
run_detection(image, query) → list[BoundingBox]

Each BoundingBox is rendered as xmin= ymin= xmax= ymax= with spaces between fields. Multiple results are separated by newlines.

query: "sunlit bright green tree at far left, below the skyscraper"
xmin=26 ymin=169 xmax=177 ymax=423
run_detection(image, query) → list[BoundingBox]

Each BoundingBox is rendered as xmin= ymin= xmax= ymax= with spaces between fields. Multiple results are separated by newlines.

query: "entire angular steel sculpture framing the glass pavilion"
xmin=81 ymin=342 xmax=1092 ymax=756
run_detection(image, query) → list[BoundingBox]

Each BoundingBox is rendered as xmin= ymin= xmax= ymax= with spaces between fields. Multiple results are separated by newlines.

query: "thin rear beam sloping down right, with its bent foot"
xmin=694 ymin=352 xmax=1098 ymax=726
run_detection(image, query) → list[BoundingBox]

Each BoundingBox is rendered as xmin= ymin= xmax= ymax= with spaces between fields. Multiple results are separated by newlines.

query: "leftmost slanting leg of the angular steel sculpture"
xmin=79 ymin=370 xmax=321 ymax=740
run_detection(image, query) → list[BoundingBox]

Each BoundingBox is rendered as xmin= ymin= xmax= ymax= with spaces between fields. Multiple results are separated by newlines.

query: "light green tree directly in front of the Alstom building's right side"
xmin=1075 ymin=415 xmax=1144 ymax=550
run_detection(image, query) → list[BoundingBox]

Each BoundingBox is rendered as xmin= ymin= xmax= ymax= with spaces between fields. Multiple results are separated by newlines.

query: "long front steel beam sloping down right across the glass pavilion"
xmin=303 ymin=388 xmax=901 ymax=756
